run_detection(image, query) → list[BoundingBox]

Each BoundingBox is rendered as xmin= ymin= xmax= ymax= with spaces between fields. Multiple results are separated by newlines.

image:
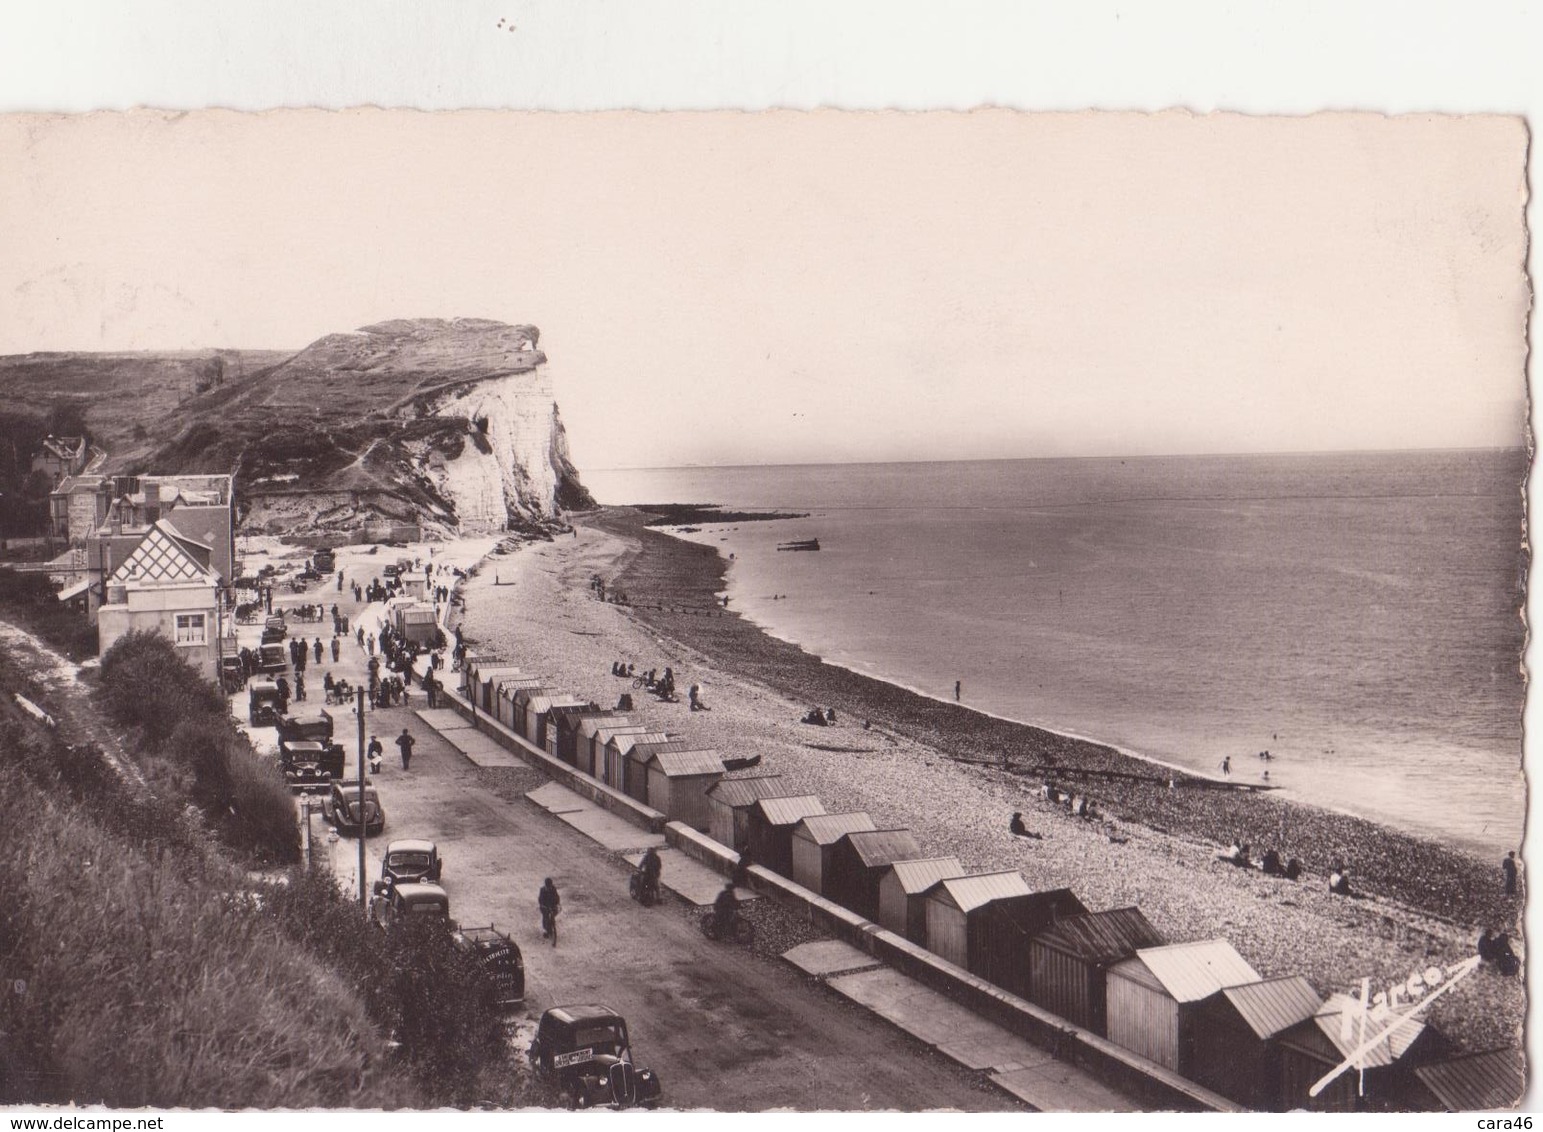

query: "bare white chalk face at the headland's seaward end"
xmin=434 ymin=366 xmax=560 ymax=534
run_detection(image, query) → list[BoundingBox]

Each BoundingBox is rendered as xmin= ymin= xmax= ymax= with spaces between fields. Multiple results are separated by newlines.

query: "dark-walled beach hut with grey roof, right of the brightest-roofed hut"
xmin=1182 ymin=975 xmax=1324 ymax=1112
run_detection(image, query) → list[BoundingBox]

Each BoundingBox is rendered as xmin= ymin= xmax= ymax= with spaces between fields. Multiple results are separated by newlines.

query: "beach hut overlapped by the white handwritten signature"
xmin=1276 ymin=993 xmax=1450 ymax=1112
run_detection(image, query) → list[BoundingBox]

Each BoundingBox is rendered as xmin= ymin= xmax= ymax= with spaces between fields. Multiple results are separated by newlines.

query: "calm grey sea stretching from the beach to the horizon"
xmin=585 ymin=449 xmax=1528 ymax=859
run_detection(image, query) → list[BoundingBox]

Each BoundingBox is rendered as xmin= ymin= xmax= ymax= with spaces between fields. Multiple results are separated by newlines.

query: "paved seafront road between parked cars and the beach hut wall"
xmin=263 ymin=571 xmax=1023 ymax=1112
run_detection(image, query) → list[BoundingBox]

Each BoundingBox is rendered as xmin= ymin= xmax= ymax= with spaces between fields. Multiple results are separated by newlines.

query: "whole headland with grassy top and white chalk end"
xmin=135 ymin=319 xmax=593 ymax=534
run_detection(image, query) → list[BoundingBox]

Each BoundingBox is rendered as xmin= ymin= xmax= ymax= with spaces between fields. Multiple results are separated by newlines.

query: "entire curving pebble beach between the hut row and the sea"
xmin=461 ymin=509 xmax=1526 ymax=1050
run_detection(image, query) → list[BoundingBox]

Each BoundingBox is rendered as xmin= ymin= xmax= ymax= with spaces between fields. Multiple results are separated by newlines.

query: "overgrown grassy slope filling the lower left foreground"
xmin=0 ymin=641 xmax=528 ymax=1109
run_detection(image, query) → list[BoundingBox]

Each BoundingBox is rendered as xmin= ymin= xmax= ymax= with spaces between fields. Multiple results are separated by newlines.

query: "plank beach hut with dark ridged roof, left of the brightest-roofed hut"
xmin=1026 ymin=908 xmax=1168 ymax=1035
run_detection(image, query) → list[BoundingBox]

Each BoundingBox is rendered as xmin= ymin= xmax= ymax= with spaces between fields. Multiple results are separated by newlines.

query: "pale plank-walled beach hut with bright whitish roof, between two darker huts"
xmin=1105 ymin=939 xmax=1259 ymax=1073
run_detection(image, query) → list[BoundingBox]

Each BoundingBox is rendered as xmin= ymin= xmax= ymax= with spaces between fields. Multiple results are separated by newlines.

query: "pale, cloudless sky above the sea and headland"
xmin=0 ymin=111 xmax=1529 ymax=472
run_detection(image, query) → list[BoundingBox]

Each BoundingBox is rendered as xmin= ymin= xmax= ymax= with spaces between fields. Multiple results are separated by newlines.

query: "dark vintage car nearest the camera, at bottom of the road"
xmin=531 ymin=1006 xmax=663 ymax=1109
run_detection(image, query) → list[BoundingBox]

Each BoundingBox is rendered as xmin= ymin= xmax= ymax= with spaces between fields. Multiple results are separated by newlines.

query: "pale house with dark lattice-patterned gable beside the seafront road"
xmin=97 ymin=520 xmax=221 ymax=679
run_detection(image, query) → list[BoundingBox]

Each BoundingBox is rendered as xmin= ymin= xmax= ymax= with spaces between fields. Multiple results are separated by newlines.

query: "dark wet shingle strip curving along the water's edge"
xmin=585 ymin=507 xmax=1515 ymax=924
